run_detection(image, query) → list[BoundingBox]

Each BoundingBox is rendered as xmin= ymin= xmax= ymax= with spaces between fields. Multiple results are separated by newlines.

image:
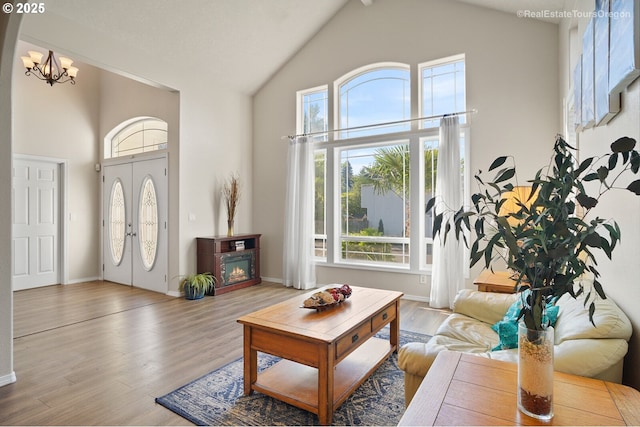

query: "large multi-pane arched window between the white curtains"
xmin=297 ymin=54 xmax=470 ymax=273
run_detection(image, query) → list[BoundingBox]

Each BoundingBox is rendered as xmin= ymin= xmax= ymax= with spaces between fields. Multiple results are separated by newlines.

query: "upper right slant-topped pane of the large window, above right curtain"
xmin=422 ymin=59 xmax=466 ymax=128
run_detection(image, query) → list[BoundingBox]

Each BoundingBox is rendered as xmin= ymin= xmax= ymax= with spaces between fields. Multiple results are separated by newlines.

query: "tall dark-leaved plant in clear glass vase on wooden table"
xmin=426 ymin=137 xmax=640 ymax=419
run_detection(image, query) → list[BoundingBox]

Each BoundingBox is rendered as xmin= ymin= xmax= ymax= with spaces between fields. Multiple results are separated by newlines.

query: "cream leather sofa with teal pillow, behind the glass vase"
xmin=398 ymin=289 xmax=632 ymax=405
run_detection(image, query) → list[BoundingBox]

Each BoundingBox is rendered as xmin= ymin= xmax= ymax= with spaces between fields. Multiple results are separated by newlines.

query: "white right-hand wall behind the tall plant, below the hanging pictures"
xmin=560 ymin=2 xmax=640 ymax=389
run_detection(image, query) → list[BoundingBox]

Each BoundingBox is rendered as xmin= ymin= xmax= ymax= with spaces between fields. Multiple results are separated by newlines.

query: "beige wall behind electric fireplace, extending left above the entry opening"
xmin=21 ymin=9 xmax=253 ymax=292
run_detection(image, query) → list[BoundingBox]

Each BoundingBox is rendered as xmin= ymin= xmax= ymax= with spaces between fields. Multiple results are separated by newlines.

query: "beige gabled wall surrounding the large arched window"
xmin=253 ymin=0 xmax=561 ymax=298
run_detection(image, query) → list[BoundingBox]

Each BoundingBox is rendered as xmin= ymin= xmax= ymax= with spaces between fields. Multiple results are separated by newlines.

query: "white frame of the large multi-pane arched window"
xmin=296 ymin=54 xmax=471 ymax=275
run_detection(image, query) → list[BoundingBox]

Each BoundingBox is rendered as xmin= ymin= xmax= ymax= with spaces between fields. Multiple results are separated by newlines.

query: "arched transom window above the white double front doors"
xmin=105 ymin=117 xmax=167 ymax=159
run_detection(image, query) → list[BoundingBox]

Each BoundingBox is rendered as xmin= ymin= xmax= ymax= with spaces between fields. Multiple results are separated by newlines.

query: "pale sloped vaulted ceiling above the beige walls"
xmin=32 ymin=0 xmax=568 ymax=94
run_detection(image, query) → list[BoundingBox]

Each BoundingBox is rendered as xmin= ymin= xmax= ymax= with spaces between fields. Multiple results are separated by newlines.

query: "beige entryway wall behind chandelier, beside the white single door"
xmin=13 ymin=42 xmax=100 ymax=283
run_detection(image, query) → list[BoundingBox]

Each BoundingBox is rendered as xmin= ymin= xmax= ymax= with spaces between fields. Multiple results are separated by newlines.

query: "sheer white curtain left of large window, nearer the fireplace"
xmin=282 ymin=136 xmax=316 ymax=289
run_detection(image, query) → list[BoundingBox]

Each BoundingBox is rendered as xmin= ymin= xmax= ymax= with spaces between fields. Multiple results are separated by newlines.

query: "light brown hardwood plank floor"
xmin=0 ymin=282 xmax=448 ymax=425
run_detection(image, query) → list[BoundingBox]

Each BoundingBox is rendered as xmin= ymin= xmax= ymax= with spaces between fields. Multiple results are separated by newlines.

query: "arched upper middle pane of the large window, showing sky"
xmin=339 ymin=68 xmax=411 ymax=139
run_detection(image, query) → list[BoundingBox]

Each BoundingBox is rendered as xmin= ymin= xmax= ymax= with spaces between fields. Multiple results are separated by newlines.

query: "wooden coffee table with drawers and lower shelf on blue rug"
xmin=238 ymin=285 xmax=403 ymax=425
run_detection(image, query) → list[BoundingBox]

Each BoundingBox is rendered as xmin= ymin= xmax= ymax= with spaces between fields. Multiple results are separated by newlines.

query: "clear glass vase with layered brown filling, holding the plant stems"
xmin=518 ymin=323 xmax=554 ymax=420
